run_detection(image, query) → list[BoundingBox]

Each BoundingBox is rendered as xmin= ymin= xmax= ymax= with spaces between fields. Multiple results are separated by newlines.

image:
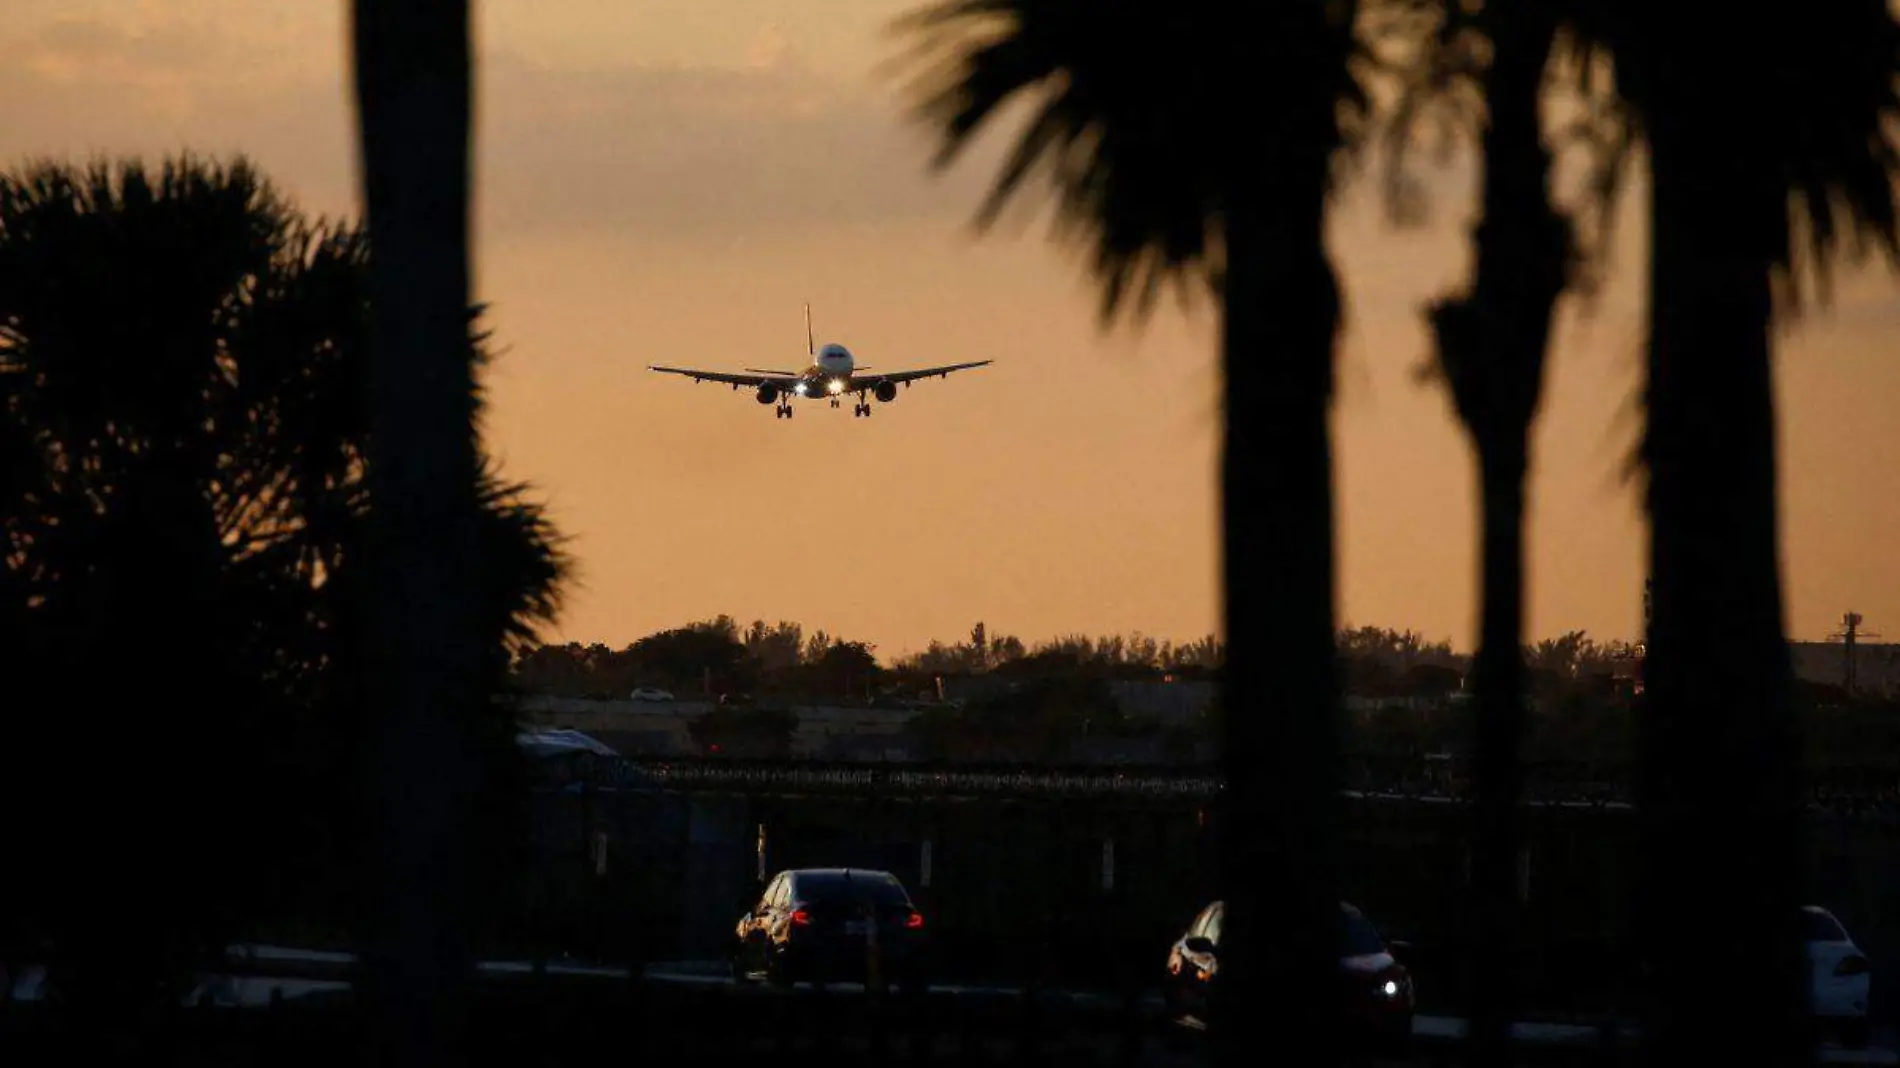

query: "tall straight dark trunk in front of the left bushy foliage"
xmin=353 ymin=0 xmax=485 ymax=1064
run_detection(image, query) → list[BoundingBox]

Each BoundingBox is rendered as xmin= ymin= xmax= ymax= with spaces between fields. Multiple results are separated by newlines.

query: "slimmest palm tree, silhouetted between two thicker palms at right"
xmin=1393 ymin=0 xmax=1573 ymax=1064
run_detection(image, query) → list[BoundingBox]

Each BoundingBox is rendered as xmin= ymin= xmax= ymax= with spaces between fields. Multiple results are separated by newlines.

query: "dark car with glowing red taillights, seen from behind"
xmin=732 ymin=868 xmax=927 ymax=990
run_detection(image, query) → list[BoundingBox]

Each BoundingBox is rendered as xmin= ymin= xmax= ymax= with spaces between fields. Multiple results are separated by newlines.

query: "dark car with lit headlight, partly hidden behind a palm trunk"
xmin=1163 ymin=901 xmax=1416 ymax=1051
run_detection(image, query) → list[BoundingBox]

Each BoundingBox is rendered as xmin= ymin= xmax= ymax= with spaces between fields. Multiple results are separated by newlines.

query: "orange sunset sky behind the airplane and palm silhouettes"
xmin=0 ymin=0 xmax=1900 ymax=656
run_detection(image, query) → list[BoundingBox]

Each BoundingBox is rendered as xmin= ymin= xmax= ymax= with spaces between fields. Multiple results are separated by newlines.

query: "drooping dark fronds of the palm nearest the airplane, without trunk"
xmin=893 ymin=0 xmax=1370 ymax=325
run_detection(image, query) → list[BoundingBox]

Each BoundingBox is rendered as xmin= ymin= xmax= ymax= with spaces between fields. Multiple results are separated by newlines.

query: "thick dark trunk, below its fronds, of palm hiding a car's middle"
xmin=1216 ymin=185 xmax=1341 ymax=1064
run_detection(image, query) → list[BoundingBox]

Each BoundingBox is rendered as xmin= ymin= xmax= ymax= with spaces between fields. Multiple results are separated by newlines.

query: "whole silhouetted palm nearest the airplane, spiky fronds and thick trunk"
xmin=901 ymin=0 xmax=1362 ymax=1060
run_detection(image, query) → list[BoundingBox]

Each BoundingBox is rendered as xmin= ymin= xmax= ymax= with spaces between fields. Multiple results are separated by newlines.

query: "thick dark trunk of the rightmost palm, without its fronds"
xmin=1640 ymin=116 xmax=1813 ymax=1064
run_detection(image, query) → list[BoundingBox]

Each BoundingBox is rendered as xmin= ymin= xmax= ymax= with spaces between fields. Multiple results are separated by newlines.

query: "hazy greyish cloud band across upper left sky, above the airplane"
xmin=0 ymin=19 xmax=1010 ymax=239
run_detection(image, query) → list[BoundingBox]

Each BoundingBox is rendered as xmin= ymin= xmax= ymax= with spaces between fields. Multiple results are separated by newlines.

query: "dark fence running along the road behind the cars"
xmin=509 ymin=766 xmax=1900 ymax=1015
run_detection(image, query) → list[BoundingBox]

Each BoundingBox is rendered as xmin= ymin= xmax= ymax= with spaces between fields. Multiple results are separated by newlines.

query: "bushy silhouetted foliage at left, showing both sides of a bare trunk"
xmin=0 ymin=158 xmax=566 ymax=998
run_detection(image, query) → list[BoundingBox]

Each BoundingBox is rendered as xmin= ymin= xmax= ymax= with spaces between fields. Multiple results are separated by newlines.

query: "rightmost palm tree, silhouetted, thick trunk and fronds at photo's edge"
xmin=1585 ymin=8 xmax=1900 ymax=1064
